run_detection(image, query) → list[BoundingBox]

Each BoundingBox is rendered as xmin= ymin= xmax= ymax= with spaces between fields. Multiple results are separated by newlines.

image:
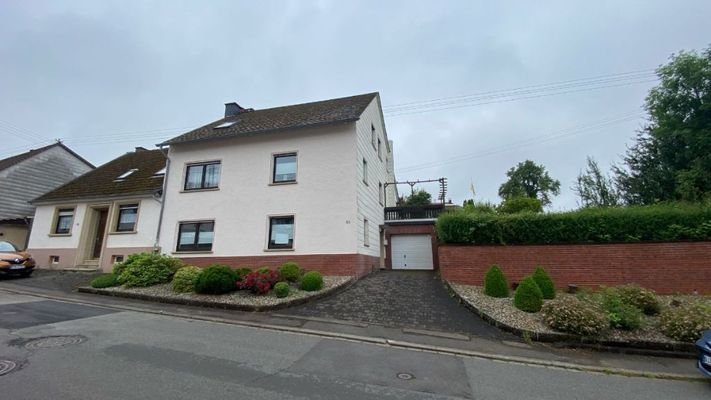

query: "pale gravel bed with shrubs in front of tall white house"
xmin=97 ymin=276 xmax=353 ymax=307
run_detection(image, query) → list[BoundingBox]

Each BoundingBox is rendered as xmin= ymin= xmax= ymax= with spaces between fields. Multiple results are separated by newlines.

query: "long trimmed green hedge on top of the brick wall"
xmin=437 ymin=204 xmax=711 ymax=244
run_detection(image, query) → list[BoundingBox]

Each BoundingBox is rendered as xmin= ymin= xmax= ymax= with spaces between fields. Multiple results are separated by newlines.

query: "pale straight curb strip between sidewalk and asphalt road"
xmin=0 ymin=287 xmax=707 ymax=382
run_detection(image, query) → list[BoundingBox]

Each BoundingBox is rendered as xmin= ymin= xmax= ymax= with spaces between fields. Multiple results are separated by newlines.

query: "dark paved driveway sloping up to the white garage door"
xmin=280 ymin=271 xmax=511 ymax=338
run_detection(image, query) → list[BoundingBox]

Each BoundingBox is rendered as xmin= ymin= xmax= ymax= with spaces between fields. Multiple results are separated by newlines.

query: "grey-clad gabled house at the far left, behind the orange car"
xmin=0 ymin=142 xmax=94 ymax=249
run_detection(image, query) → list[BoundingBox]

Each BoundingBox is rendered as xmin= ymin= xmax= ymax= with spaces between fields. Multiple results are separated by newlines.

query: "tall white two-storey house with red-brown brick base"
xmin=158 ymin=93 xmax=397 ymax=276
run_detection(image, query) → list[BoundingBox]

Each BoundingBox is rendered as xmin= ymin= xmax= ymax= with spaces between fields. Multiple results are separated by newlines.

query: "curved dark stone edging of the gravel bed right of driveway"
xmin=442 ymin=280 xmax=697 ymax=359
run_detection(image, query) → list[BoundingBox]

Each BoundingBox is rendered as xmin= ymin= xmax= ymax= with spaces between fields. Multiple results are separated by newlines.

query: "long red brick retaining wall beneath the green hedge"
xmin=439 ymin=242 xmax=711 ymax=294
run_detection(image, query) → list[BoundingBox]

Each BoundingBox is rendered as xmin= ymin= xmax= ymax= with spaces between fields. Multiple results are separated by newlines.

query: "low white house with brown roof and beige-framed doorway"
xmin=28 ymin=147 xmax=166 ymax=270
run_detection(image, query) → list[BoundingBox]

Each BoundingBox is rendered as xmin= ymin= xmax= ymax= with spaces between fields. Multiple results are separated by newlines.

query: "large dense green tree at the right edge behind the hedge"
xmin=614 ymin=47 xmax=711 ymax=204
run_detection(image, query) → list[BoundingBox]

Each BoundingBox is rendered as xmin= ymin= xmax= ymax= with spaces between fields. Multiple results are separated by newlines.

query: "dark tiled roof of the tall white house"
xmin=163 ymin=93 xmax=378 ymax=144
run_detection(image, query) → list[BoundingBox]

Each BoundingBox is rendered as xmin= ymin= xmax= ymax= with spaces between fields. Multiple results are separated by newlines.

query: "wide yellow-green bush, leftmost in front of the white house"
xmin=114 ymin=253 xmax=183 ymax=287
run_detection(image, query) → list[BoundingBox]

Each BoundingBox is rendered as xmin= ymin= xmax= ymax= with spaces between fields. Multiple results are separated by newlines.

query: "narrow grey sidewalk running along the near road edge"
xmin=0 ymin=272 xmax=701 ymax=379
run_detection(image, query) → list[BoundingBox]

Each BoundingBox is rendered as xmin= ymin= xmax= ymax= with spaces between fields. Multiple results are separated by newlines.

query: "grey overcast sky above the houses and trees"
xmin=0 ymin=0 xmax=711 ymax=209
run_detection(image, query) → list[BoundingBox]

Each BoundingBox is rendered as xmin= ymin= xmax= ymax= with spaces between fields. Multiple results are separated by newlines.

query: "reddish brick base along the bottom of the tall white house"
xmin=183 ymin=254 xmax=380 ymax=277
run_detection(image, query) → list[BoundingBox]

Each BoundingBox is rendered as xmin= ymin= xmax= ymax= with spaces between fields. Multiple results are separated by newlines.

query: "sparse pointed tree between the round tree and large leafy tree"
xmin=573 ymin=157 xmax=621 ymax=207
